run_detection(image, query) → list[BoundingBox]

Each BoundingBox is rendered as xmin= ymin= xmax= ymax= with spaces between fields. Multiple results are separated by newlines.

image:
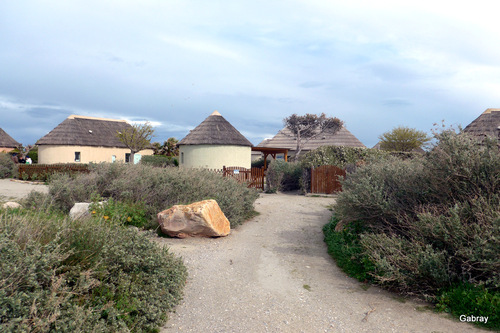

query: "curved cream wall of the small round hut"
xmin=179 ymin=145 xmax=252 ymax=169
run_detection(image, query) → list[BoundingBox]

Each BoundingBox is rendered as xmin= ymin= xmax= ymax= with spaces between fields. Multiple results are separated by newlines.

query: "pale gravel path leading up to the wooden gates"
xmin=157 ymin=194 xmax=484 ymax=333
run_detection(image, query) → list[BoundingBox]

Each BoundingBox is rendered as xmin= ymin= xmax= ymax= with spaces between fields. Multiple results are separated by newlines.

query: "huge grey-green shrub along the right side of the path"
xmin=335 ymin=131 xmax=500 ymax=326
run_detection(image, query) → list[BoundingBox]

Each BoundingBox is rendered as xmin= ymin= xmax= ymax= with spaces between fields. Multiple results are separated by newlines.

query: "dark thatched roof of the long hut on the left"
xmin=36 ymin=115 xmax=130 ymax=148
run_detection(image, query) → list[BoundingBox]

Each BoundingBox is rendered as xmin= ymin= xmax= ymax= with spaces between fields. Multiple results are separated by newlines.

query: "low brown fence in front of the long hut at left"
xmin=19 ymin=164 xmax=90 ymax=181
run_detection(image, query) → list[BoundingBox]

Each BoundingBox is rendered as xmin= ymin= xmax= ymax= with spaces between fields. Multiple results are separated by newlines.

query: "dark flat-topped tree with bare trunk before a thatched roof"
xmin=283 ymin=113 xmax=343 ymax=161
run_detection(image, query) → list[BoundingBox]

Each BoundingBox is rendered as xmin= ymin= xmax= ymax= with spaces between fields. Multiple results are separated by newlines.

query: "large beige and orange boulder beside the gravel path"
xmin=157 ymin=200 xmax=231 ymax=238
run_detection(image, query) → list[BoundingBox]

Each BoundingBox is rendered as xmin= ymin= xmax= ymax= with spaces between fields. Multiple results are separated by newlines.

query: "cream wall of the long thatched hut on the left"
xmin=38 ymin=145 xmax=153 ymax=164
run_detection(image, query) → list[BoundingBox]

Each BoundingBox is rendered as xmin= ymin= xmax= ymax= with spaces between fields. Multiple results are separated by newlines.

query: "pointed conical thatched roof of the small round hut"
xmin=178 ymin=111 xmax=252 ymax=147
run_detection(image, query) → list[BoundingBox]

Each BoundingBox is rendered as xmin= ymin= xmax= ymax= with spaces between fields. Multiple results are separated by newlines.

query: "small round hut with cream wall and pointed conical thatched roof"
xmin=178 ymin=111 xmax=252 ymax=169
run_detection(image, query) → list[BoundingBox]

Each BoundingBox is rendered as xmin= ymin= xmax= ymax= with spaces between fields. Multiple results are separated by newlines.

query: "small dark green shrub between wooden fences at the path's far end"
xmin=266 ymin=160 xmax=302 ymax=193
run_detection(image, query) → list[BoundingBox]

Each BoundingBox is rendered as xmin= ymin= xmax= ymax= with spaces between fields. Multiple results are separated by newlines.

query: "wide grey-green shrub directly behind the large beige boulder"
xmin=49 ymin=163 xmax=259 ymax=227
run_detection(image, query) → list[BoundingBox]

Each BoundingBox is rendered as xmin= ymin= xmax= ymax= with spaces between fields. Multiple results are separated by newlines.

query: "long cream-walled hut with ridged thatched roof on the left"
xmin=36 ymin=115 xmax=153 ymax=164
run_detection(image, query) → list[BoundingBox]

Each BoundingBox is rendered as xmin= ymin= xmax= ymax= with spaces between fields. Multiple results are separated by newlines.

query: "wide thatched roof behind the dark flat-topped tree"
xmin=257 ymin=126 xmax=366 ymax=153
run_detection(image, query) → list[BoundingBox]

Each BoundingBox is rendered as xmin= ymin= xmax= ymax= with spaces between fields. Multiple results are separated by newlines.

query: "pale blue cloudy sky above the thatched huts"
xmin=0 ymin=0 xmax=500 ymax=147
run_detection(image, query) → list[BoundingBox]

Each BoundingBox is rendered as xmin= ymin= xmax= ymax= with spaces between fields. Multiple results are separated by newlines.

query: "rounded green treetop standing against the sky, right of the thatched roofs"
xmin=379 ymin=126 xmax=431 ymax=152
